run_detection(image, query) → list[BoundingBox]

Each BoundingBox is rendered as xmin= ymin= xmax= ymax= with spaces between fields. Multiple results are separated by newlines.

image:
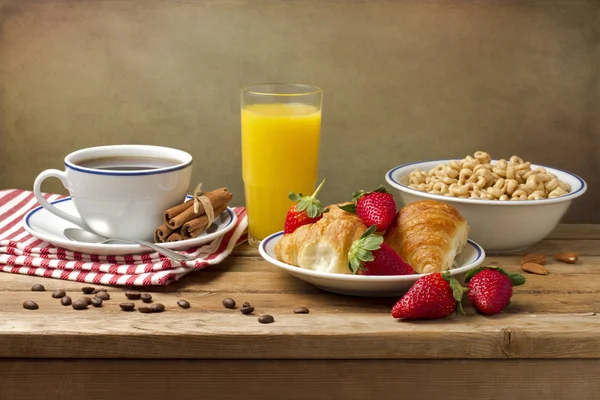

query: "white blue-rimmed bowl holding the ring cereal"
xmin=385 ymin=160 xmax=587 ymax=253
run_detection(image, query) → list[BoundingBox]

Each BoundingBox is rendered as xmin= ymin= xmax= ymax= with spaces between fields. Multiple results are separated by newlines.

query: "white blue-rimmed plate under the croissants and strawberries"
xmin=258 ymin=231 xmax=485 ymax=297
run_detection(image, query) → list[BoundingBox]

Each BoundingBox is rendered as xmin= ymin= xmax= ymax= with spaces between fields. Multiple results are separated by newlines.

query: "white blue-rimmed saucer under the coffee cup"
xmin=22 ymin=196 xmax=237 ymax=256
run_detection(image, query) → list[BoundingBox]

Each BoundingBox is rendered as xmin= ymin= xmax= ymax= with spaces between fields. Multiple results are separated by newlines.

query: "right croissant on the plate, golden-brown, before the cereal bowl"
xmin=384 ymin=200 xmax=469 ymax=273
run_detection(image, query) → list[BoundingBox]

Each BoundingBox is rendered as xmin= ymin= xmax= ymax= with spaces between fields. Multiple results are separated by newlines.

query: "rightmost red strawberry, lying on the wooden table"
xmin=465 ymin=266 xmax=525 ymax=315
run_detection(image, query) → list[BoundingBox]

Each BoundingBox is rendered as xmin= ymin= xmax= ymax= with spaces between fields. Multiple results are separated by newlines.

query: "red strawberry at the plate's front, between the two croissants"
xmin=348 ymin=225 xmax=415 ymax=275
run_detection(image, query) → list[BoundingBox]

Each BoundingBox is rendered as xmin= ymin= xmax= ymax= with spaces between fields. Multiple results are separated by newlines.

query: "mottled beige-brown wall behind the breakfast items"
xmin=0 ymin=0 xmax=600 ymax=223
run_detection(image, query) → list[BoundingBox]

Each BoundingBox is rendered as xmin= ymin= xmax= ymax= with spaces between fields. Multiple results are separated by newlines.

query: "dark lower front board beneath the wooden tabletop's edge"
xmin=0 ymin=359 xmax=600 ymax=400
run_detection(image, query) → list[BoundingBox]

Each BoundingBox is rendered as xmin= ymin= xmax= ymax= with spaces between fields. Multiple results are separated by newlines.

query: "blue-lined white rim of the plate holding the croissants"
xmin=258 ymin=231 xmax=485 ymax=282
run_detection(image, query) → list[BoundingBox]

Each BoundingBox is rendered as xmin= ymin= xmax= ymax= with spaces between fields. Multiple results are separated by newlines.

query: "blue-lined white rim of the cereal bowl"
xmin=385 ymin=158 xmax=587 ymax=206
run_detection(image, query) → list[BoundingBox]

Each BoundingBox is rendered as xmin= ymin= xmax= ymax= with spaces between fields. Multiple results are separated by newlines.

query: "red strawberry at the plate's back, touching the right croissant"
xmin=340 ymin=185 xmax=396 ymax=232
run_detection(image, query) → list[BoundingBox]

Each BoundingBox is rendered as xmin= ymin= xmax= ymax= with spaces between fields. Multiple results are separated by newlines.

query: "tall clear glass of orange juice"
xmin=241 ymin=83 xmax=323 ymax=246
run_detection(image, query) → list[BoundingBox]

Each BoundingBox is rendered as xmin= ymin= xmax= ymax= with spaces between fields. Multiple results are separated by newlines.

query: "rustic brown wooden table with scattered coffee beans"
xmin=0 ymin=225 xmax=600 ymax=400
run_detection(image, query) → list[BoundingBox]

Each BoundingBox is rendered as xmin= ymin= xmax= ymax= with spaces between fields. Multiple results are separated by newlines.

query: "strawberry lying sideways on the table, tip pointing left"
xmin=392 ymin=272 xmax=466 ymax=319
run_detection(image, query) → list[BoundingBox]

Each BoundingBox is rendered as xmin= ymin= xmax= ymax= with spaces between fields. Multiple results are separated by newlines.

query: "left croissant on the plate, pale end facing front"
xmin=275 ymin=205 xmax=367 ymax=274
